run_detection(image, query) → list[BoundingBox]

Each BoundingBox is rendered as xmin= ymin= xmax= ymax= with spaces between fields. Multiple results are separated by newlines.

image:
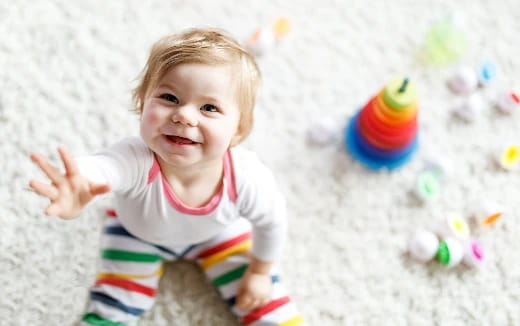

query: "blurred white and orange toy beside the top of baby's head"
xmin=246 ymin=17 xmax=291 ymax=56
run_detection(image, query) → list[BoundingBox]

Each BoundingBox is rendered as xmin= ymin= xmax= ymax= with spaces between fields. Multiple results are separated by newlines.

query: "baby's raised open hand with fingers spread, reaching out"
xmin=29 ymin=147 xmax=110 ymax=219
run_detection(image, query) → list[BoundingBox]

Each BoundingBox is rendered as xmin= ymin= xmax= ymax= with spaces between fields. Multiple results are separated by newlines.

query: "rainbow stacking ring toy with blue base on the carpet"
xmin=345 ymin=78 xmax=418 ymax=170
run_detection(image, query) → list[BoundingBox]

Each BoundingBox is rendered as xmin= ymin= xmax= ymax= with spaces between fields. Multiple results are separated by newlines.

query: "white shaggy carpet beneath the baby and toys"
xmin=0 ymin=0 xmax=520 ymax=326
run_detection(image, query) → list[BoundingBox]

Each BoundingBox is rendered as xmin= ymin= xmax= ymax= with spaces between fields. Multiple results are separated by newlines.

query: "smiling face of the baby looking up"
xmin=141 ymin=64 xmax=240 ymax=171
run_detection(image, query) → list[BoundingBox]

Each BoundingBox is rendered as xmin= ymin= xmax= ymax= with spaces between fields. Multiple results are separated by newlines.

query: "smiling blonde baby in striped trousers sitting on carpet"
xmin=30 ymin=29 xmax=303 ymax=326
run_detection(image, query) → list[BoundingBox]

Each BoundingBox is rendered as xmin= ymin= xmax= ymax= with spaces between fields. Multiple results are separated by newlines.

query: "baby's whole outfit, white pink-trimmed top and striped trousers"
xmin=78 ymin=138 xmax=303 ymax=326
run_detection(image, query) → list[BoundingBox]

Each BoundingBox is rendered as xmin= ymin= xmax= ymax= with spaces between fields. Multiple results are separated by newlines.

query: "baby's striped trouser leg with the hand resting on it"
xmin=189 ymin=219 xmax=303 ymax=326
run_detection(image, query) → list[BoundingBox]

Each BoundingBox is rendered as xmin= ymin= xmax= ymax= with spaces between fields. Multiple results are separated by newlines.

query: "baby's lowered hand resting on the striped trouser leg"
xmin=237 ymin=270 xmax=273 ymax=311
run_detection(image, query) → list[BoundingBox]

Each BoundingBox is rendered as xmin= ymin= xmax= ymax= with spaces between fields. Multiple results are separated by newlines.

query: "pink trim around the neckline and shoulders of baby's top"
xmin=148 ymin=150 xmax=237 ymax=215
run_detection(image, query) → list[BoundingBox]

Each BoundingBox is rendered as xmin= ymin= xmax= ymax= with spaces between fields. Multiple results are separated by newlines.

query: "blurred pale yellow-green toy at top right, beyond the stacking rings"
xmin=422 ymin=14 xmax=468 ymax=65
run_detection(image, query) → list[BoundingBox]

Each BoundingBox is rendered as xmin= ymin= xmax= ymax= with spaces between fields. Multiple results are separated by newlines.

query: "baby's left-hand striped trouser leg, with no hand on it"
xmin=81 ymin=211 xmax=171 ymax=326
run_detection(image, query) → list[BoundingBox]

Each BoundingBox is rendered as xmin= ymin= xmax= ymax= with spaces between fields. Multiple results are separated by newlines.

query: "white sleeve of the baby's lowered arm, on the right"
xmin=234 ymin=153 xmax=287 ymax=262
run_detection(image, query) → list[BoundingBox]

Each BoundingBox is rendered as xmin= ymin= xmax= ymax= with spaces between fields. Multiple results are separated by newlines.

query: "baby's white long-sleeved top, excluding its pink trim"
xmin=77 ymin=137 xmax=286 ymax=261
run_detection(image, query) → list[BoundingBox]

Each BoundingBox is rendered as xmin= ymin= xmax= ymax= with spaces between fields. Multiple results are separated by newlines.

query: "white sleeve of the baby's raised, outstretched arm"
xmin=76 ymin=138 xmax=153 ymax=193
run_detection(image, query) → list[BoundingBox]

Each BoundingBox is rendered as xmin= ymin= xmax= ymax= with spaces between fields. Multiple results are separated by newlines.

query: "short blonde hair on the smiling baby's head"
xmin=132 ymin=29 xmax=261 ymax=145
